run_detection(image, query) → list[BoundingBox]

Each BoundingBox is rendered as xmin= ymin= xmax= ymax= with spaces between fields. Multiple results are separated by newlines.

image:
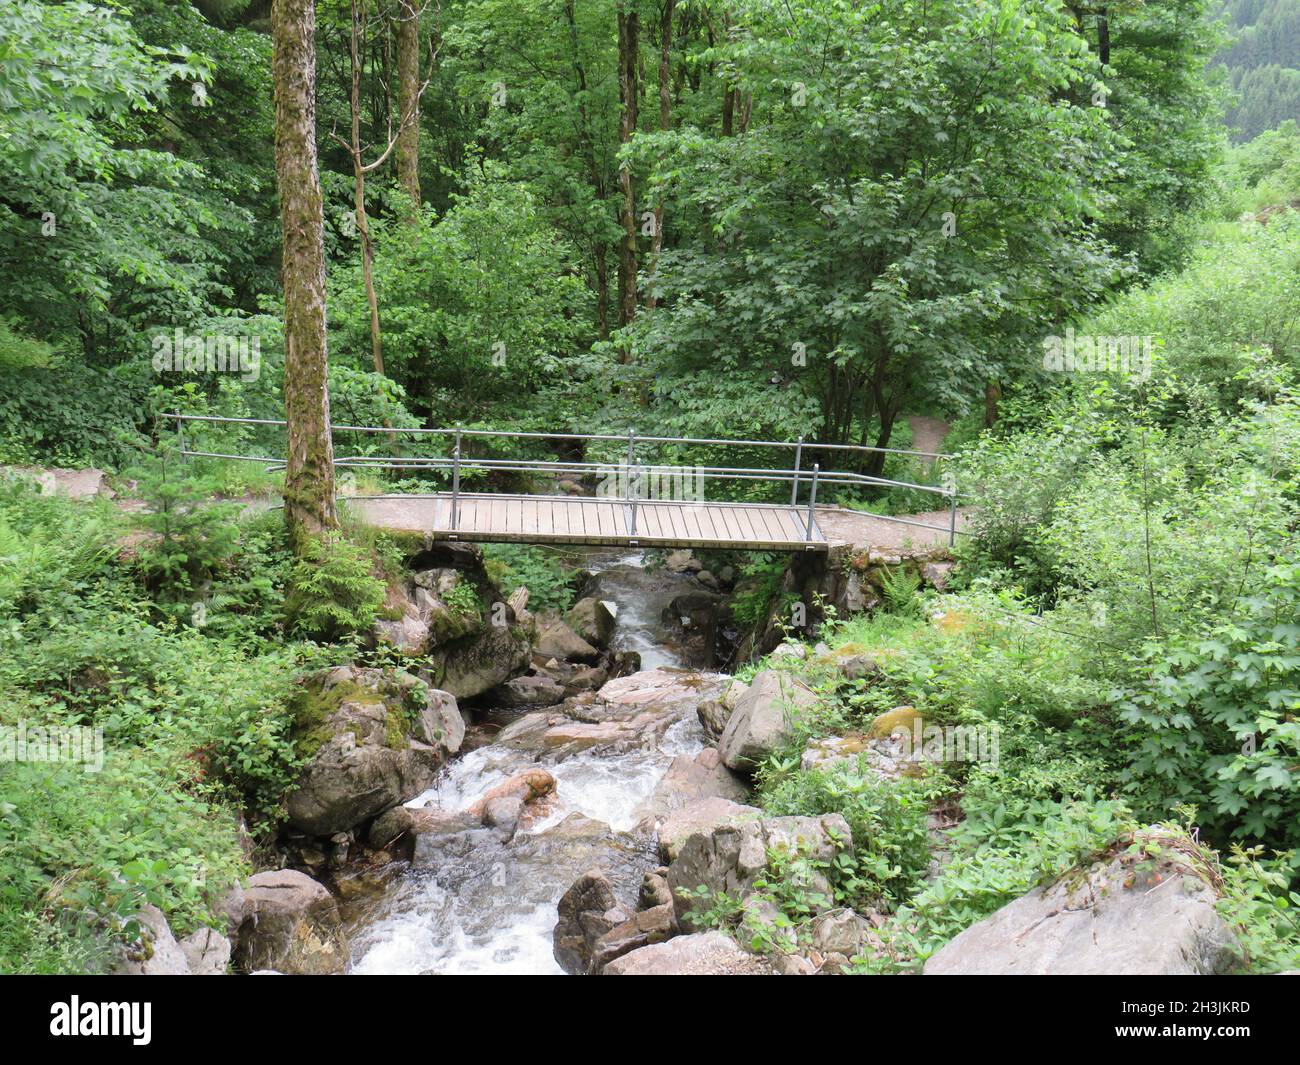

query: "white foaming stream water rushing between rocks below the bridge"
xmin=350 ymin=555 xmax=705 ymax=974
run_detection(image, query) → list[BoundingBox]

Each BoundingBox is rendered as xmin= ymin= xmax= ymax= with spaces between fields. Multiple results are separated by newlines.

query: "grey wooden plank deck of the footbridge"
xmin=347 ymin=493 xmax=827 ymax=551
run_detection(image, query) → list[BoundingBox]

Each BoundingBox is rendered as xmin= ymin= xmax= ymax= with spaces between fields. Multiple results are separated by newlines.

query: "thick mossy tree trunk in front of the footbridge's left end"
xmin=270 ymin=0 xmax=338 ymax=549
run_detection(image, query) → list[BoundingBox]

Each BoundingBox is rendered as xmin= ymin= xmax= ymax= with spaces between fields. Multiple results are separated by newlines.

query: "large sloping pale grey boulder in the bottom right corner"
xmin=924 ymin=830 xmax=1235 ymax=975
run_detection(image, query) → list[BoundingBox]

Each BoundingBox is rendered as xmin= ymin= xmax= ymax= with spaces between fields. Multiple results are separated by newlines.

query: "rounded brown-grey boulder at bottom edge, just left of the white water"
xmin=235 ymin=869 xmax=348 ymax=975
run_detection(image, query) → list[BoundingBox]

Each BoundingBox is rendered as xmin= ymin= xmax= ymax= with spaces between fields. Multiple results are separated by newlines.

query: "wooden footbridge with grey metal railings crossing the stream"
xmin=166 ymin=414 xmax=958 ymax=551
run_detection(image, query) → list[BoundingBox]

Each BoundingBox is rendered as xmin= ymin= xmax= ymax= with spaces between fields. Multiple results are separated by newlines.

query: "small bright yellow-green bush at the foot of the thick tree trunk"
xmin=286 ymin=533 xmax=385 ymax=641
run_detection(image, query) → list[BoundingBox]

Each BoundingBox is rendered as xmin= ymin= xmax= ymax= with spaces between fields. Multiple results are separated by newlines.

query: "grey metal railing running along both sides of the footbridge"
xmin=161 ymin=412 xmax=957 ymax=546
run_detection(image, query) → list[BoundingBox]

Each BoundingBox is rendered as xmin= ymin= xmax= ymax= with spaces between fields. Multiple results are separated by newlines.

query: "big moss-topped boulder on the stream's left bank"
xmin=287 ymin=666 xmax=452 ymax=836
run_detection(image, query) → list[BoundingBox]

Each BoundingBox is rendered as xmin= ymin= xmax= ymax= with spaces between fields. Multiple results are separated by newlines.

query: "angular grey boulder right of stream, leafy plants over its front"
xmin=668 ymin=814 xmax=852 ymax=921
